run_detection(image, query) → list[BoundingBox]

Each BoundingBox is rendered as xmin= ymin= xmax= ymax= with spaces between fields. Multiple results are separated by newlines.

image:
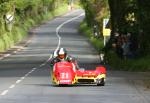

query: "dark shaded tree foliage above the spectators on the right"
xmin=109 ymin=0 xmax=150 ymax=55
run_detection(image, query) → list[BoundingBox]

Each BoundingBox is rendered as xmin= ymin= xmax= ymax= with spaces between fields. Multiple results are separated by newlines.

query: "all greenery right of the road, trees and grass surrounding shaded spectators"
xmin=81 ymin=0 xmax=150 ymax=70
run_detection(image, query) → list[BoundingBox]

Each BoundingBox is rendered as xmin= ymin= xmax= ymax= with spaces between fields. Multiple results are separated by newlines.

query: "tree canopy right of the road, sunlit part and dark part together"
xmin=81 ymin=0 xmax=150 ymax=54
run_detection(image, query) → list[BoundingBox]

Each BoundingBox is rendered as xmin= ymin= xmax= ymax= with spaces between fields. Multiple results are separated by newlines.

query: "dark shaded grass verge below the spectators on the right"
xmin=107 ymin=51 xmax=150 ymax=71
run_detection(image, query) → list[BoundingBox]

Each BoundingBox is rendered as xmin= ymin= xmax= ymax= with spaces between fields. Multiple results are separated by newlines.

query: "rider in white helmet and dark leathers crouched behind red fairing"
xmin=50 ymin=48 xmax=79 ymax=68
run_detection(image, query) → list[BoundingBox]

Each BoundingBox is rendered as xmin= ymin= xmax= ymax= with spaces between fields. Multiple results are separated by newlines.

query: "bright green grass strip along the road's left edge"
xmin=0 ymin=4 xmax=68 ymax=52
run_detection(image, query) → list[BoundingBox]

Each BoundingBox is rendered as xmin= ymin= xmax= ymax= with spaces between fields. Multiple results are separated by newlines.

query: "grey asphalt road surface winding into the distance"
xmin=0 ymin=10 xmax=150 ymax=103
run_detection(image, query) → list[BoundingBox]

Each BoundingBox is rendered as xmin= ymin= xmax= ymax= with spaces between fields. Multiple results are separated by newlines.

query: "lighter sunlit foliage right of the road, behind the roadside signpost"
xmin=81 ymin=0 xmax=109 ymax=34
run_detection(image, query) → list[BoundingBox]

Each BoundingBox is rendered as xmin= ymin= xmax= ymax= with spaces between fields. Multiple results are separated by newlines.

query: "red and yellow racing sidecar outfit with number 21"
xmin=51 ymin=61 xmax=106 ymax=86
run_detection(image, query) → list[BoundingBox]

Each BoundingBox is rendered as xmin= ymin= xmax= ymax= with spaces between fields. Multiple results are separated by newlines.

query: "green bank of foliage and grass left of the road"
xmin=0 ymin=0 xmax=67 ymax=51
